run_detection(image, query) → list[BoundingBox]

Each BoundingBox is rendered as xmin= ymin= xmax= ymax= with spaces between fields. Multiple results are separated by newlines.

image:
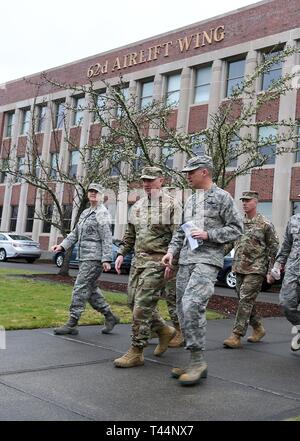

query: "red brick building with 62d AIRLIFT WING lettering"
xmin=0 ymin=0 xmax=300 ymax=250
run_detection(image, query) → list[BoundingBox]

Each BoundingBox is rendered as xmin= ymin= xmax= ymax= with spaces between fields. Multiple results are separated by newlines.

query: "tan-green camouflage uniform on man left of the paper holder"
xmin=118 ymin=191 xmax=178 ymax=348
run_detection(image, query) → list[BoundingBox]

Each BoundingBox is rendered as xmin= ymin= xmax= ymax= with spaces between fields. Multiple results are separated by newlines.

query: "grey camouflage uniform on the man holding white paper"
xmin=168 ymin=180 xmax=243 ymax=351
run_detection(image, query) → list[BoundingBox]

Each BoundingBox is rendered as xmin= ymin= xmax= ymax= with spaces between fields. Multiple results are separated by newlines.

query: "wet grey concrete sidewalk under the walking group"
xmin=0 ymin=318 xmax=300 ymax=422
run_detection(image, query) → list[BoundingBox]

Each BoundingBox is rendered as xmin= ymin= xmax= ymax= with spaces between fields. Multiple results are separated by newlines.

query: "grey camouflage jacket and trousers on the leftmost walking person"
xmin=60 ymin=204 xmax=112 ymax=320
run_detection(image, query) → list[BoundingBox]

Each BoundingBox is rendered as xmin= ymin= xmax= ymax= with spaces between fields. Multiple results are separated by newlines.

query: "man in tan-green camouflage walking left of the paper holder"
xmin=114 ymin=167 xmax=181 ymax=368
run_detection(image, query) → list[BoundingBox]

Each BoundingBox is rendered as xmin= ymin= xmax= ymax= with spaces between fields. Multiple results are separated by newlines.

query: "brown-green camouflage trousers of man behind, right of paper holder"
xmin=233 ymin=273 xmax=264 ymax=337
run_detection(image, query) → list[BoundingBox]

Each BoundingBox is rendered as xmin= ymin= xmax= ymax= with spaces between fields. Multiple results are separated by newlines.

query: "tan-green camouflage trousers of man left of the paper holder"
xmin=128 ymin=266 xmax=170 ymax=348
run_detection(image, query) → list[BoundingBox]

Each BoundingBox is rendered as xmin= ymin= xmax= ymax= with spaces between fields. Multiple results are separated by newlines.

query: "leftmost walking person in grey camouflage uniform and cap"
xmin=52 ymin=183 xmax=119 ymax=335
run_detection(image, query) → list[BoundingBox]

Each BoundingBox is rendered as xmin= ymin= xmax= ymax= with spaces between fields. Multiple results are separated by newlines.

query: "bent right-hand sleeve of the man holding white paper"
xmin=207 ymin=194 xmax=244 ymax=244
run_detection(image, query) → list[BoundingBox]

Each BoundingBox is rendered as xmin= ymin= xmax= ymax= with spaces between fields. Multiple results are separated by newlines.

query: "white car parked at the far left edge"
xmin=0 ymin=232 xmax=42 ymax=263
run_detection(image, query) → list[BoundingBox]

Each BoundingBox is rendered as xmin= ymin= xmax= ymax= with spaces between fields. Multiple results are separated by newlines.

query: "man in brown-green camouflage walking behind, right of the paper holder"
xmin=224 ymin=191 xmax=278 ymax=348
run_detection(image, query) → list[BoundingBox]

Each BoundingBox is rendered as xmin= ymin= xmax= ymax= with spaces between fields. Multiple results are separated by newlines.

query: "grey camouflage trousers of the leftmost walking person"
xmin=70 ymin=260 xmax=110 ymax=320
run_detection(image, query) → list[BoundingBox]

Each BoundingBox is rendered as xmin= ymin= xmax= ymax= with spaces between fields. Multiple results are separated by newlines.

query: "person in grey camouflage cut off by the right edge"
xmin=269 ymin=213 xmax=300 ymax=351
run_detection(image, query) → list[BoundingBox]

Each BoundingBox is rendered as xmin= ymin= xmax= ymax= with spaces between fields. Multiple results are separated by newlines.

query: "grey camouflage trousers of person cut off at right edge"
xmin=279 ymin=272 xmax=300 ymax=326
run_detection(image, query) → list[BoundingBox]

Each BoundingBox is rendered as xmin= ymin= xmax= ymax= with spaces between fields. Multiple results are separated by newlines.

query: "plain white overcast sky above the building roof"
xmin=0 ymin=0 xmax=257 ymax=84
